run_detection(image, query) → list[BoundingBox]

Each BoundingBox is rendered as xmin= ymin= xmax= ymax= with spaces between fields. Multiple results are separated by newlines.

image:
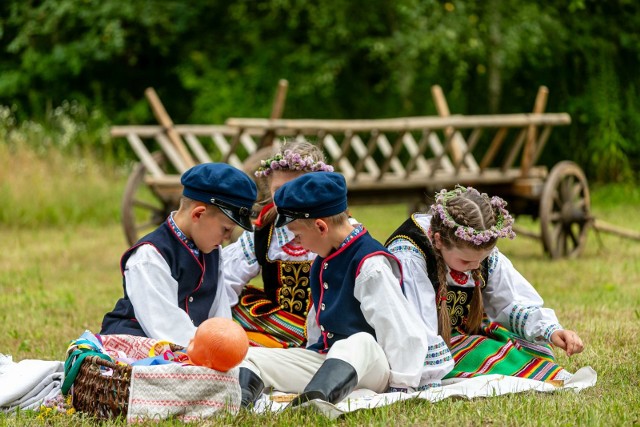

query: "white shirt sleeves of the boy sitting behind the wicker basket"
xmin=124 ymin=244 xmax=231 ymax=347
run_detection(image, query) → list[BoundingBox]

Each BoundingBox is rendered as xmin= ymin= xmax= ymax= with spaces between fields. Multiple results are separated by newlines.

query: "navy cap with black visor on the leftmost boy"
xmin=180 ymin=163 xmax=258 ymax=231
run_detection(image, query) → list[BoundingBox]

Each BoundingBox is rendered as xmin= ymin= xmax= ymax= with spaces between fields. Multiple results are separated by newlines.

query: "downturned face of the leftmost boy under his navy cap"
xmin=191 ymin=206 xmax=236 ymax=254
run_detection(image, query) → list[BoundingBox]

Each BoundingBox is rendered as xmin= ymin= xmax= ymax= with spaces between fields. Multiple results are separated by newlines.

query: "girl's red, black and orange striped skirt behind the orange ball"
xmin=231 ymin=287 xmax=306 ymax=348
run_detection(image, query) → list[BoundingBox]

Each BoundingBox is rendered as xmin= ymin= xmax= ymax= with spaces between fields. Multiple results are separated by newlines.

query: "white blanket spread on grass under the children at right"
xmin=254 ymin=366 xmax=598 ymax=419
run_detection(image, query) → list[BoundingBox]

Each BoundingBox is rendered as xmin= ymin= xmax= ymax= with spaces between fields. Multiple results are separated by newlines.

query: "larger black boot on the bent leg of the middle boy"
xmin=289 ymin=359 xmax=358 ymax=407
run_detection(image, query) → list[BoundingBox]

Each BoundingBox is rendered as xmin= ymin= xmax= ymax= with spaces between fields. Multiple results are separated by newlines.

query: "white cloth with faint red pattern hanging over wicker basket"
xmin=127 ymin=363 xmax=241 ymax=423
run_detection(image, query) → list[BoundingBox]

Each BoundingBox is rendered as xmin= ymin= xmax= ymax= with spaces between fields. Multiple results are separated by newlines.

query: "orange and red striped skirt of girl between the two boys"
xmin=232 ymin=294 xmax=306 ymax=348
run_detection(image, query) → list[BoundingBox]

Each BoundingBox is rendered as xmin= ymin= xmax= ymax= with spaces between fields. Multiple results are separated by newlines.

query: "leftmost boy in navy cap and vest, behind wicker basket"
xmin=100 ymin=163 xmax=257 ymax=347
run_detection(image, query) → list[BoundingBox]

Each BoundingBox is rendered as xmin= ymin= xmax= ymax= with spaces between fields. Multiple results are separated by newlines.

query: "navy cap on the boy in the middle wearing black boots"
xmin=273 ymin=172 xmax=347 ymax=227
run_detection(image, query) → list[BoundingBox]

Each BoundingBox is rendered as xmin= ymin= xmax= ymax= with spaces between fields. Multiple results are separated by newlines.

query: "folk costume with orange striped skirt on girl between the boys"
xmin=222 ymin=203 xmax=316 ymax=348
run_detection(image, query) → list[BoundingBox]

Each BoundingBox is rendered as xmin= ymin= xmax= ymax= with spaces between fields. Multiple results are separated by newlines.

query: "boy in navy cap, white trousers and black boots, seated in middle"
xmin=240 ymin=172 xmax=453 ymax=406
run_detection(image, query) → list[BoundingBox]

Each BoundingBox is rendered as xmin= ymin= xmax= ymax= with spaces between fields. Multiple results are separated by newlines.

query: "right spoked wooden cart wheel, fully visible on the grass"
xmin=540 ymin=161 xmax=591 ymax=259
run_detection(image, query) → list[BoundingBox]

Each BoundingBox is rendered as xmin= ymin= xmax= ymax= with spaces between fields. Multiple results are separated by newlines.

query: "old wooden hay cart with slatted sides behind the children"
xmin=111 ymin=86 xmax=593 ymax=258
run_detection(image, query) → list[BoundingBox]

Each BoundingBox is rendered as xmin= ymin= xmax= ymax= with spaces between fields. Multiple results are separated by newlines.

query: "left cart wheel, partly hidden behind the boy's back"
xmin=121 ymin=152 xmax=177 ymax=245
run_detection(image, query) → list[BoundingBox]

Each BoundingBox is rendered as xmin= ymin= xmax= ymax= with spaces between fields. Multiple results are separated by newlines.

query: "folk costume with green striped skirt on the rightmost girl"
xmin=386 ymin=214 xmax=570 ymax=380
